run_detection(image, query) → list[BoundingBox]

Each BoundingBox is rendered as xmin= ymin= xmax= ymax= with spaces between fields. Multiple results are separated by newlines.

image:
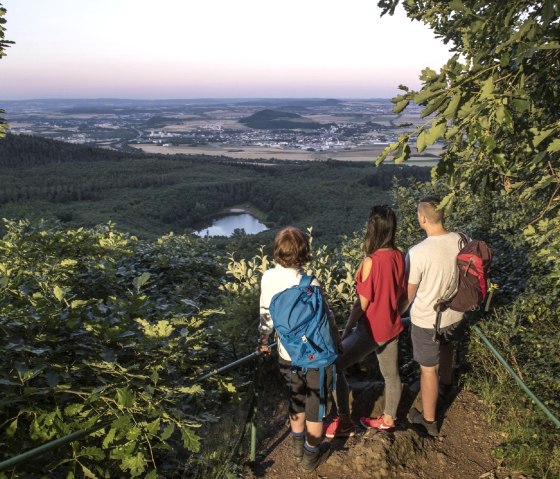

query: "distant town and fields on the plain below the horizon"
xmin=2 ymin=99 xmax=440 ymax=161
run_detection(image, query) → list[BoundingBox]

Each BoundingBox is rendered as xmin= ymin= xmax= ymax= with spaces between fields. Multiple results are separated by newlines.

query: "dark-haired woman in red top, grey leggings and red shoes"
xmin=324 ymin=205 xmax=406 ymax=437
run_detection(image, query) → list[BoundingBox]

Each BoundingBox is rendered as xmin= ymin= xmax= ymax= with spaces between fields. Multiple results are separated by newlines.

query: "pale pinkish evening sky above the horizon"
xmin=0 ymin=0 xmax=451 ymax=100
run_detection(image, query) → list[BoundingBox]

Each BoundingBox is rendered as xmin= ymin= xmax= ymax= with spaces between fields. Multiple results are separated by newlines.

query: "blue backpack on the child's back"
xmin=270 ymin=276 xmax=338 ymax=369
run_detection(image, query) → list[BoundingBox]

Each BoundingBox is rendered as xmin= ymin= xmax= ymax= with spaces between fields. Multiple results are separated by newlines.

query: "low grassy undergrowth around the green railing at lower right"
xmin=467 ymin=306 xmax=560 ymax=479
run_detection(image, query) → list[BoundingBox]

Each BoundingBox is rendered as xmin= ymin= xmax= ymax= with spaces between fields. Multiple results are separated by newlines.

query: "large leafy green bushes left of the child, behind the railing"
xmin=0 ymin=221 xmax=235 ymax=477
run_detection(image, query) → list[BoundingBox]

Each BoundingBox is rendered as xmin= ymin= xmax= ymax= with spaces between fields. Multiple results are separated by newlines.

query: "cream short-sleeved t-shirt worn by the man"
xmin=406 ymin=233 xmax=463 ymax=329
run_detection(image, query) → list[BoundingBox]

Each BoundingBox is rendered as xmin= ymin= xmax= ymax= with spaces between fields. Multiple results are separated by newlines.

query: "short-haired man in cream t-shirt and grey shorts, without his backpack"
xmin=401 ymin=196 xmax=463 ymax=436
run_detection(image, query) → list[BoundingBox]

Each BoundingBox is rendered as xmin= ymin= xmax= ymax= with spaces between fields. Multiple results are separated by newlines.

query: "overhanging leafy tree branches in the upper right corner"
xmin=378 ymin=0 xmax=560 ymax=286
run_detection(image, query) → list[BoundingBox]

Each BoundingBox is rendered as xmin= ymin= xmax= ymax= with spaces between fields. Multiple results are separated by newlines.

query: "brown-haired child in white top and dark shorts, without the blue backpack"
xmin=258 ymin=227 xmax=341 ymax=472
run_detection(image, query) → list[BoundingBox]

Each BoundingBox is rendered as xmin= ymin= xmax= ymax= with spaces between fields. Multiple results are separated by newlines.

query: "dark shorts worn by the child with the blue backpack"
xmin=279 ymin=358 xmax=333 ymax=422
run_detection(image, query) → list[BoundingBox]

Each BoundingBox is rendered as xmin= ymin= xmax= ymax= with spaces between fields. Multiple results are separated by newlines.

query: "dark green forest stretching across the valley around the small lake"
xmin=0 ymin=135 xmax=430 ymax=243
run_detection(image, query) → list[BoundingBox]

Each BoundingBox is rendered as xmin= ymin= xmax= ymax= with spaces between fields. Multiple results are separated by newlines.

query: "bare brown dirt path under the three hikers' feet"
xmin=246 ymin=383 xmax=524 ymax=479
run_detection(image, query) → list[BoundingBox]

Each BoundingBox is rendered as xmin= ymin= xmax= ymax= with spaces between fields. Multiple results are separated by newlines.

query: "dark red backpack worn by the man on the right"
xmin=434 ymin=233 xmax=492 ymax=335
